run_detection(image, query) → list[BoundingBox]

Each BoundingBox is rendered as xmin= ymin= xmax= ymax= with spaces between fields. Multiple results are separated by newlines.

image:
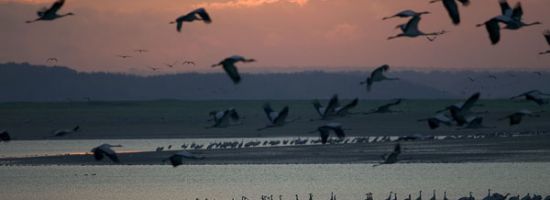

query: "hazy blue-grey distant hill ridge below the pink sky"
xmin=0 ymin=63 xmax=550 ymax=102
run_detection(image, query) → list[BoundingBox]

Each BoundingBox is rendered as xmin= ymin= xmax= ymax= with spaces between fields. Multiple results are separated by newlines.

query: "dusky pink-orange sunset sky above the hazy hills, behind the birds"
xmin=0 ymin=0 xmax=550 ymax=74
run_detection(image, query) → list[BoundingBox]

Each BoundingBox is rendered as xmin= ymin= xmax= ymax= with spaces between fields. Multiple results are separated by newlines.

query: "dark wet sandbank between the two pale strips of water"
xmin=4 ymin=135 xmax=550 ymax=165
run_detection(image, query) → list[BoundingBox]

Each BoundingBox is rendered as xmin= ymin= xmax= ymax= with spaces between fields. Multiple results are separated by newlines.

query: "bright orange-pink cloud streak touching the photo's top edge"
xmin=194 ymin=0 xmax=309 ymax=9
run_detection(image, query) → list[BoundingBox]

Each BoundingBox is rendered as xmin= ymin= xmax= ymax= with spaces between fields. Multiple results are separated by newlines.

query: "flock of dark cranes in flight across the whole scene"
xmin=0 ymin=0 xmax=550 ymax=166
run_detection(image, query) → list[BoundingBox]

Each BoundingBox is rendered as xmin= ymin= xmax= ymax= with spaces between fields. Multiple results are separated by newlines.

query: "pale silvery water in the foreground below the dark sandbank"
xmin=0 ymin=163 xmax=550 ymax=200
